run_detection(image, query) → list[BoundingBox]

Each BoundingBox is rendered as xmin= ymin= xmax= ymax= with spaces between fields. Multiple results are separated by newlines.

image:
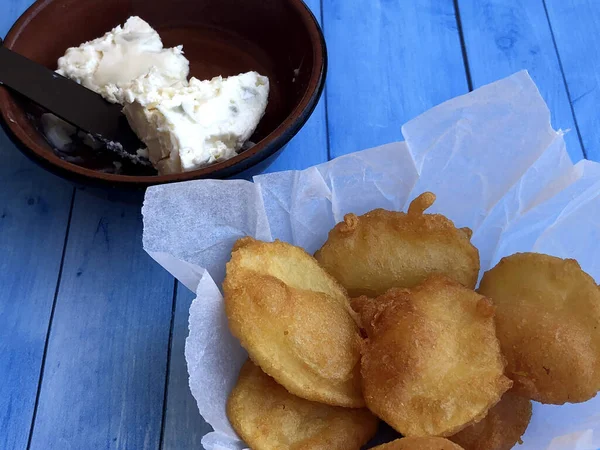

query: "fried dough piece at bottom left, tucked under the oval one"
xmin=227 ymin=361 xmax=379 ymax=450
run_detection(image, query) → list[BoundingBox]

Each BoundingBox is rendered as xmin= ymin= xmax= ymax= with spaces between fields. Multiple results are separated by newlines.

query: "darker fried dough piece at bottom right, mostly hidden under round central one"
xmin=448 ymin=391 xmax=531 ymax=450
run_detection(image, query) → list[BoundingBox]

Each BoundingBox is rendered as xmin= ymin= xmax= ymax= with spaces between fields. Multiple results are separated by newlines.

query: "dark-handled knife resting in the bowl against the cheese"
xmin=0 ymin=38 xmax=145 ymax=159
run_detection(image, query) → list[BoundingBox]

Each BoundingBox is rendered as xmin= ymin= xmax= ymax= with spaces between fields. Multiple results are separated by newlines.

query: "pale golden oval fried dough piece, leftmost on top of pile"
xmin=223 ymin=238 xmax=364 ymax=408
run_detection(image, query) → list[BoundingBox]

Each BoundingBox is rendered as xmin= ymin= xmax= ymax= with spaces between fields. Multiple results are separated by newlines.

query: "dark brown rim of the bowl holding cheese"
xmin=0 ymin=0 xmax=328 ymax=188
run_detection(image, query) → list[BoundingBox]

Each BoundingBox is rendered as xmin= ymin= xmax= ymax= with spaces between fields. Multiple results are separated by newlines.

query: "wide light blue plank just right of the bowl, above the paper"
xmin=323 ymin=0 xmax=468 ymax=156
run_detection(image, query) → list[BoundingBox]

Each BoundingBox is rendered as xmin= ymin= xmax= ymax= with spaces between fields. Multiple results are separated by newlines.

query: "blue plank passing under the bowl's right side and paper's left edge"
xmin=162 ymin=0 xmax=328 ymax=450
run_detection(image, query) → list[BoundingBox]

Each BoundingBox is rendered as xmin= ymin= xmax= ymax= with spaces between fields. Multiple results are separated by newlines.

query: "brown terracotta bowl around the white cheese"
xmin=0 ymin=0 xmax=327 ymax=188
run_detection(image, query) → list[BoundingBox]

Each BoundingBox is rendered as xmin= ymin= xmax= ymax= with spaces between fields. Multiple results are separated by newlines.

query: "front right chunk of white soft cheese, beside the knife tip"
xmin=123 ymin=72 xmax=269 ymax=174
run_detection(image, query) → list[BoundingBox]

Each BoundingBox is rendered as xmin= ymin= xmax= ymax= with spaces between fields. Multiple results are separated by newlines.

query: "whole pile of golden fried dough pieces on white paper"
xmin=223 ymin=192 xmax=600 ymax=450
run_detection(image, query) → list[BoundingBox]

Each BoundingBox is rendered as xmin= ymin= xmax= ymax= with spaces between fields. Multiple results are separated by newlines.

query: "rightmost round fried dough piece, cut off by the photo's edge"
xmin=479 ymin=253 xmax=600 ymax=405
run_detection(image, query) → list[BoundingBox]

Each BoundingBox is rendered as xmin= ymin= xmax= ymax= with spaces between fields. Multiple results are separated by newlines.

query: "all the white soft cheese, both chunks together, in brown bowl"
xmin=57 ymin=17 xmax=269 ymax=174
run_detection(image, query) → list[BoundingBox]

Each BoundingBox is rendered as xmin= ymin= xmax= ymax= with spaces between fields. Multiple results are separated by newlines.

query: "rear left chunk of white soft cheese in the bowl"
xmin=57 ymin=16 xmax=189 ymax=104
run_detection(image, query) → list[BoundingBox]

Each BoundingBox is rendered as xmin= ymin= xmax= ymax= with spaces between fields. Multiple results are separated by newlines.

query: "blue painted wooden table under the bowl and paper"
xmin=0 ymin=0 xmax=600 ymax=450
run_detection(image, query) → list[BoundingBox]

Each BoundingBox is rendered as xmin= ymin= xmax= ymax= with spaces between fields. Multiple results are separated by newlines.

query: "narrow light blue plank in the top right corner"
xmin=545 ymin=0 xmax=600 ymax=161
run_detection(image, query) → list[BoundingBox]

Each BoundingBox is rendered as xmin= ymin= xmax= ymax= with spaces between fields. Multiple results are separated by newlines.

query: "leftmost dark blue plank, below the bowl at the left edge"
xmin=0 ymin=130 xmax=73 ymax=449
